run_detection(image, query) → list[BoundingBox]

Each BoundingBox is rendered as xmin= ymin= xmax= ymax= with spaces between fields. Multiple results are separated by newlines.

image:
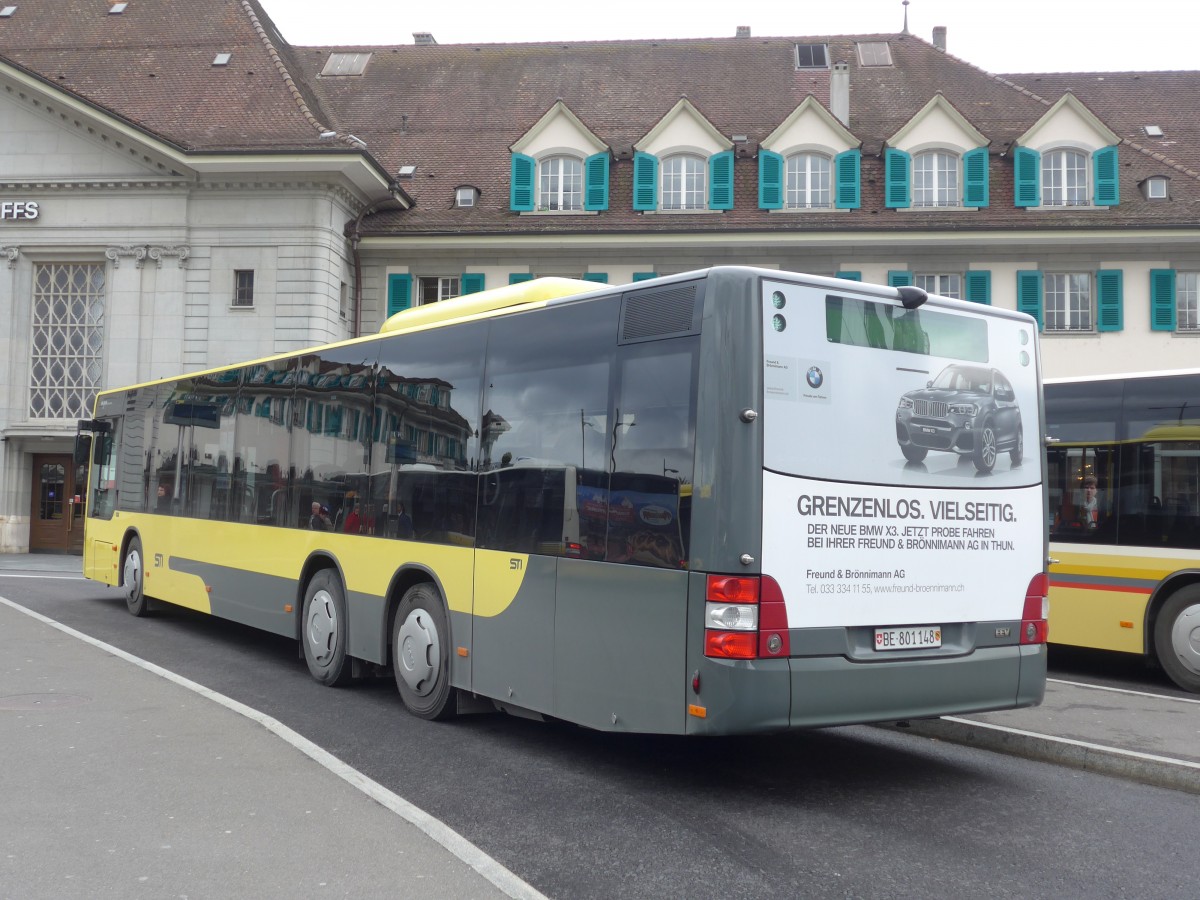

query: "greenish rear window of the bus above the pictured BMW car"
xmin=826 ymin=294 xmax=988 ymax=362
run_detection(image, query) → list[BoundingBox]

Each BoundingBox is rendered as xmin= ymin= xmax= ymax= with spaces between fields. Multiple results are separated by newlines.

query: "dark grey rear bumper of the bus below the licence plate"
xmin=788 ymin=644 xmax=1046 ymax=728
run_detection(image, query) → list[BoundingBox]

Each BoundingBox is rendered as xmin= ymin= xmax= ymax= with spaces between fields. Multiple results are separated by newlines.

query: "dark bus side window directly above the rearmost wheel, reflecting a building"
xmin=374 ymin=323 xmax=487 ymax=546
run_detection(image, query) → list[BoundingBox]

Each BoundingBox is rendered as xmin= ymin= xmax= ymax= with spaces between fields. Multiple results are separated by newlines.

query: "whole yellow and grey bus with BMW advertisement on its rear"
xmin=80 ymin=268 xmax=1046 ymax=734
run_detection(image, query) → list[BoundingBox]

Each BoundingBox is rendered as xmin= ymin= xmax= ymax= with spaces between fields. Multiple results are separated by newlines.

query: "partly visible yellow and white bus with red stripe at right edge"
xmin=1045 ymin=370 xmax=1200 ymax=691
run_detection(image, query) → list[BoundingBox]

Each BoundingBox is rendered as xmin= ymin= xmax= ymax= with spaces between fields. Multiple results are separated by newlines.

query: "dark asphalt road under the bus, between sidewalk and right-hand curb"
xmin=9 ymin=576 xmax=1200 ymax=900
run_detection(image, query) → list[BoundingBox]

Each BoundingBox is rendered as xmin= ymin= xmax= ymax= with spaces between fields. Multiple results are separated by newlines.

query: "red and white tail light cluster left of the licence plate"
xmin=704 ymin=575 xmax=791 ymax=659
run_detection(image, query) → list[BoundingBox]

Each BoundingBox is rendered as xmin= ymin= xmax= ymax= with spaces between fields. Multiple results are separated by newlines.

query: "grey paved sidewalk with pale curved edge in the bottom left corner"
xmin=0 ymin=556 xmax=541 ymax=900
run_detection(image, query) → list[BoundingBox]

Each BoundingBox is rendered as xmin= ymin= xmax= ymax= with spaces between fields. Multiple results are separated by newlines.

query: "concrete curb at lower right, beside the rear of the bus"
xmin=883 ymin=715 xmax=1200 ymax=794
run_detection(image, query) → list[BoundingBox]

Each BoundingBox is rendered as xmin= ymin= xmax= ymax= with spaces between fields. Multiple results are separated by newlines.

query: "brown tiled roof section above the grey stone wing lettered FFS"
xmin=0 ymin=0 xmax=333 ymax=151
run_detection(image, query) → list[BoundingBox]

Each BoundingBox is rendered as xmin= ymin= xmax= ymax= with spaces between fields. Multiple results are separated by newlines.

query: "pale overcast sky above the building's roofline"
xmin=262 ymin=0 xmax=1200 ymax=72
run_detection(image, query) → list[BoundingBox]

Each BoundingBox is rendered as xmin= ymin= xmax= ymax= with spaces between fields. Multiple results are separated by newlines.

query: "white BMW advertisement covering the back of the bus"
xmin=762 ymin=280 xmax=1044 ymax=628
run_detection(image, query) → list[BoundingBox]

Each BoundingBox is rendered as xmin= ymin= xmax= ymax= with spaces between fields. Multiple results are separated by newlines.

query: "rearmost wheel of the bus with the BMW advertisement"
xmin=391 ymin=583 xmax=458 ymax=720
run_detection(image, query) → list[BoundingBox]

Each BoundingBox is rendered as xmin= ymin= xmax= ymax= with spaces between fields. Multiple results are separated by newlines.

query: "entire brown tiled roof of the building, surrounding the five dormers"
xmin=0 ymin=0 xmax=1200 ymax=234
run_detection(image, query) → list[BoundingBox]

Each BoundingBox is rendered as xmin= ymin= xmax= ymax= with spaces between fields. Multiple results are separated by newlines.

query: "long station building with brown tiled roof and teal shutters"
xmin=0 ymin=0 xmax=1200 ymax=550
